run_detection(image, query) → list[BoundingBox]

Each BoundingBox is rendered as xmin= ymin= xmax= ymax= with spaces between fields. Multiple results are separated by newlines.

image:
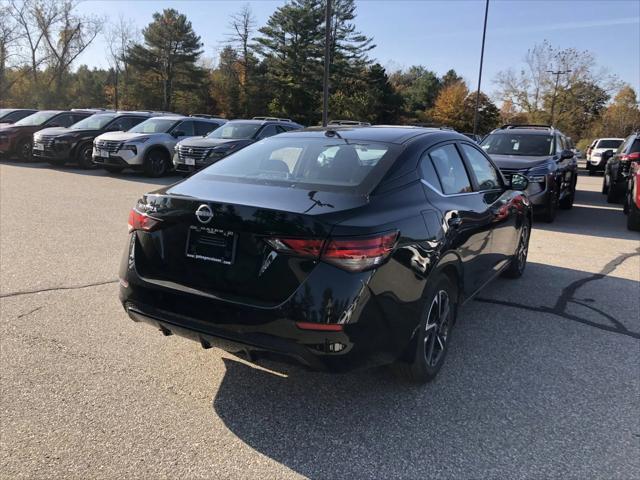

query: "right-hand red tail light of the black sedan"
xmin=267 ymin=232 xmax=398 ymax=272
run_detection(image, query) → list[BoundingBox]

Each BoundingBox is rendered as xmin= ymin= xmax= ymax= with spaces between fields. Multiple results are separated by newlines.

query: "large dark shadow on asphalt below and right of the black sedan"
xmin=213 ymin=260 xmax=640 ymax=478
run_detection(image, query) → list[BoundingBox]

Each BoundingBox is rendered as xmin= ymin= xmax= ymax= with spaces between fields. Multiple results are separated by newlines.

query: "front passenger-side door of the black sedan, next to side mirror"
xmin=460 ymin=143 xmax=519 ymax=271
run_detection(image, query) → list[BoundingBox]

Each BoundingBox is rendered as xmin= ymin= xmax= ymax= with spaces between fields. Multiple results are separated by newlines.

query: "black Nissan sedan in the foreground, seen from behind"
xmin=119 ymin=127 xmax=531 ymax=382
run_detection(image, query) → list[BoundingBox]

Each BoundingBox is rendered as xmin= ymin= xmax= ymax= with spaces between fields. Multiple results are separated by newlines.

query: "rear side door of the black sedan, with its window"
xmin=421 ymin=142 xmax=496 ymax=295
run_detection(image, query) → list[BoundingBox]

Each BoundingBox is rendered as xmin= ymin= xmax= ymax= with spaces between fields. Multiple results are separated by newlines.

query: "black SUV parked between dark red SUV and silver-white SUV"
xmin=33 ymin=112 xmax=151 ymax=168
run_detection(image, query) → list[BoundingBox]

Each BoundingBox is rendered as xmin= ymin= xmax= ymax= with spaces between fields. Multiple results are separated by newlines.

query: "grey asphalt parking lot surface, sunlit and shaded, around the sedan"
xmin=0 ymin=163 xmax=640 ymax=479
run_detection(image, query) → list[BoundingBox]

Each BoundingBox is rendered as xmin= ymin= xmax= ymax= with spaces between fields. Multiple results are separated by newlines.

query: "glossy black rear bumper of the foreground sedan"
xmin=120 ymin=236 xmax=404 ymax=372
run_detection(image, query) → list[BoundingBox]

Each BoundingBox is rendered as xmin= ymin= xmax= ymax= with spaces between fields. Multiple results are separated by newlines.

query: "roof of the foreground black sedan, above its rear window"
xmin=278 ymin=125 xmax=462 ymax=144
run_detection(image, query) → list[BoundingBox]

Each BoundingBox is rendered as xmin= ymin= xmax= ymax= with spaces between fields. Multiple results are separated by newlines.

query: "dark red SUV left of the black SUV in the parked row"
xmin=0 ymin=110 xmax=99 ymax=161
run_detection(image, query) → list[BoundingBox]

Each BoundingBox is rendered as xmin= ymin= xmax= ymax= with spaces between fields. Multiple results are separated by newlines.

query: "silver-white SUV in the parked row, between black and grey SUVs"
xmin=93 ymin=115 xmax=224 ymax=177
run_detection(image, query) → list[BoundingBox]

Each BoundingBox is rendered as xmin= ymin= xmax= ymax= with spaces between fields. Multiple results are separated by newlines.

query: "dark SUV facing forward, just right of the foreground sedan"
xmin=480 ymin=125 xmax=578 ymax=222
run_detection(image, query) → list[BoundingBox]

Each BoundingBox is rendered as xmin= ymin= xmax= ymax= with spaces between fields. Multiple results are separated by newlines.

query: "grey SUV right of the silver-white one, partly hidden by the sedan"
xmin=173 ymin=117 xmax=302 ymax=173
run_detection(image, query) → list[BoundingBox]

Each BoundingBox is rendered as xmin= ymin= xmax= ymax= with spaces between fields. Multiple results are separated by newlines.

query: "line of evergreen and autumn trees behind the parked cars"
xmin=0 ymin=0 xmax=640 ymax=140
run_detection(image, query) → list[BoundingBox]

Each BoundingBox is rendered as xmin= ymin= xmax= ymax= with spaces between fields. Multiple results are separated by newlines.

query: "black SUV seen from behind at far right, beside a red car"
xmin=602 ymin=132 xmax=640 ymax=203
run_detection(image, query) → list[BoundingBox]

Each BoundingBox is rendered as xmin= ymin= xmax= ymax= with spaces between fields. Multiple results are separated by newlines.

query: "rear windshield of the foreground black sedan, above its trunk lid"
xmin=197 ymin=137 xmax=398 ymax=193
